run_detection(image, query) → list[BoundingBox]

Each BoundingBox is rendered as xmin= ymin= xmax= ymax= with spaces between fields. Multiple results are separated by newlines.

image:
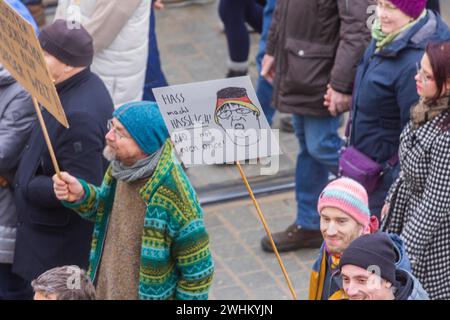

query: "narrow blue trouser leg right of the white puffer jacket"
xmin=143 ymin=8 xmax=167 ymax=101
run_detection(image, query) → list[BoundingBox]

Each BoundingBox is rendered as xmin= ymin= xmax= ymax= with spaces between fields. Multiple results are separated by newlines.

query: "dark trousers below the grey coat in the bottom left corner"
xmin=0 ymin=263 xmax=33 ymax=300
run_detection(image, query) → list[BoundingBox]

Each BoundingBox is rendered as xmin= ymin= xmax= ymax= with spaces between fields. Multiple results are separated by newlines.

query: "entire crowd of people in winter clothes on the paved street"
xmin=0 ymin=0 xmax=450 ymax=300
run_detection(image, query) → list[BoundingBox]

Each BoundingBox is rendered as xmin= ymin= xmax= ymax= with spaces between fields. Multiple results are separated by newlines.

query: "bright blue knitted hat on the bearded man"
xmin=113 ymin=101 xmax=169 ymax=155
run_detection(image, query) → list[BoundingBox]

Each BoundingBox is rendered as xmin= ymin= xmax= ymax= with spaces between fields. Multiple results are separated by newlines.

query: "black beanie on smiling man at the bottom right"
xmin=339 ymin=232 xmax=397 ymax=284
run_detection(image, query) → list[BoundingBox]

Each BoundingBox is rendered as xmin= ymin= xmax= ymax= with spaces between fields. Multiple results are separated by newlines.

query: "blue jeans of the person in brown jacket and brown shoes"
xmin=292 ymin=115 xmax=343 ymax=230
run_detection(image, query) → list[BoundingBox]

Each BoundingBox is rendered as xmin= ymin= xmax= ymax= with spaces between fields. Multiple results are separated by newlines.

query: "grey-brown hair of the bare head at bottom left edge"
xmin=31 ymin=266 xmax=95 ymax=300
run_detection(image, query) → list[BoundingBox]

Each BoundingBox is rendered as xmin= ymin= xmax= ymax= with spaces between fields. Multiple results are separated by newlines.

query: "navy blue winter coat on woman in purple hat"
xmin=351 ymin=10 xmax=450 ymax=163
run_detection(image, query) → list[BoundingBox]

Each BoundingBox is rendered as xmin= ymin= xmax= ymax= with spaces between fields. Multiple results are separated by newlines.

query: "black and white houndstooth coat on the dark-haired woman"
xmin=382 ymin=111 xmax=450 ymax=299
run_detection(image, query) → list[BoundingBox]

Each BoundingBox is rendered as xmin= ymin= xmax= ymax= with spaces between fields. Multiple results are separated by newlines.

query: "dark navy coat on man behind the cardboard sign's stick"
xmin=13 ymin=69 xmax=113 ymax=280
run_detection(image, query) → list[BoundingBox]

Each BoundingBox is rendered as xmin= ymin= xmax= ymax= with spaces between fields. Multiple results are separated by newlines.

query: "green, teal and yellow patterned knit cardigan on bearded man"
xmin=64 ymin=140 xmax=214 ymax=300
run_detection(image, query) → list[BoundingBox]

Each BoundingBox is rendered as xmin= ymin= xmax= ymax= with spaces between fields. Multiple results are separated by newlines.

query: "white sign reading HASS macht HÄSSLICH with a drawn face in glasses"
xmin=153 ymin=77 xmax=280 ymax=166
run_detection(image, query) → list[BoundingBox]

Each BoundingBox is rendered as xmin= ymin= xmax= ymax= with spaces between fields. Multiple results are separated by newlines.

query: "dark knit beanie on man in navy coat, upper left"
xmin=39 ymin=20 xmax=94 ymax=67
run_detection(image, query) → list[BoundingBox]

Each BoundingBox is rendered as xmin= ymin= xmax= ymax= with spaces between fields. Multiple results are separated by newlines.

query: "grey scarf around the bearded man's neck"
xmin=111 ymin=148 xmax=163 ymax=183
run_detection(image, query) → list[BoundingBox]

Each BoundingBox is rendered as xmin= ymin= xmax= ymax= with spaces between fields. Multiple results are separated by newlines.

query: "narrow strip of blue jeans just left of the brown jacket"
xmin=256 ymin=0 xmax=276 ymax=125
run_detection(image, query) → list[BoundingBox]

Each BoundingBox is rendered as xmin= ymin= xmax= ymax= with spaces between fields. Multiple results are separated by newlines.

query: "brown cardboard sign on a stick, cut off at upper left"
xmin=0 ymin=0 xmax=69 ymax=128
